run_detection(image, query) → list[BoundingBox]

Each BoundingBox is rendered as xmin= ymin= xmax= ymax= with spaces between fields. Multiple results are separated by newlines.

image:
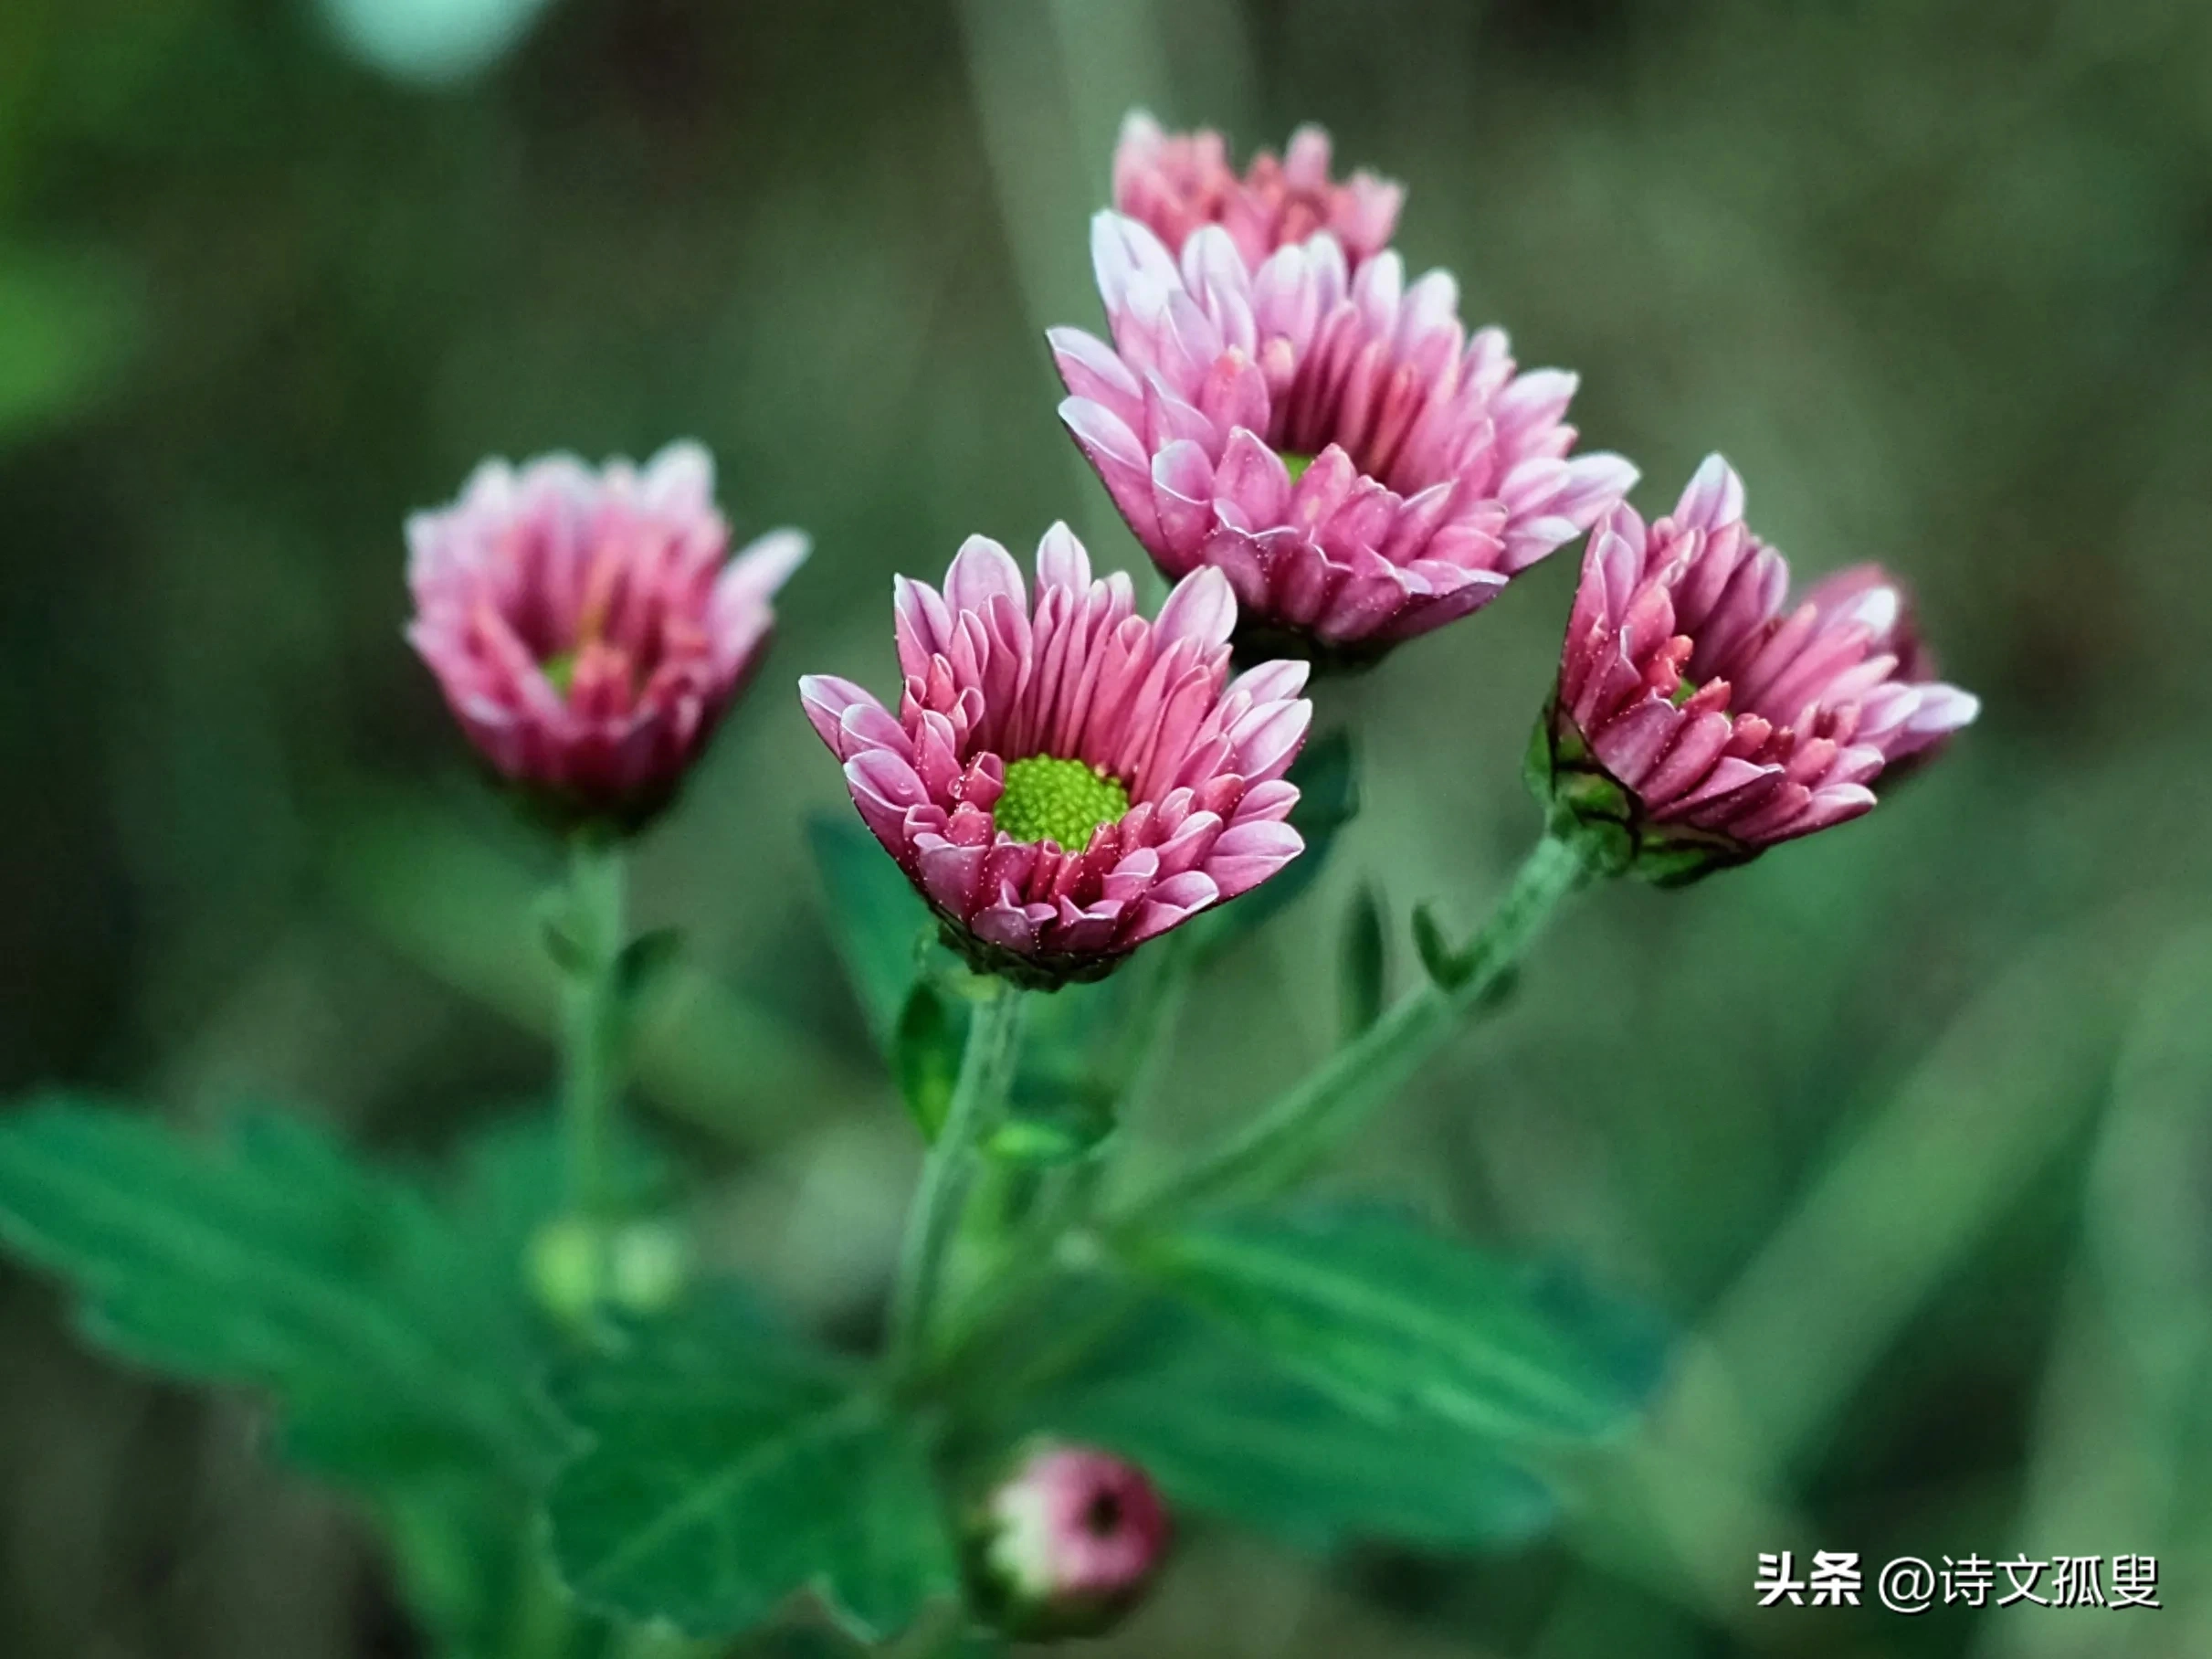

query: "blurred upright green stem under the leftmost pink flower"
xmin=562 ymin=830 xmax=624 ymax=1223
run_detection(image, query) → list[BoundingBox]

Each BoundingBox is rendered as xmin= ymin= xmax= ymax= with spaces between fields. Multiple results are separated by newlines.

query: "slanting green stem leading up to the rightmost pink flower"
xmin=1108 ymin=836 xmax=1590 ymax=1228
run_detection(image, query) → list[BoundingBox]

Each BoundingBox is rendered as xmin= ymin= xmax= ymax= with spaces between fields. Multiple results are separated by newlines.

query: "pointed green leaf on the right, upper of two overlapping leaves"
xmin=1126 ymin=1208 xmax=1661 ymax=1440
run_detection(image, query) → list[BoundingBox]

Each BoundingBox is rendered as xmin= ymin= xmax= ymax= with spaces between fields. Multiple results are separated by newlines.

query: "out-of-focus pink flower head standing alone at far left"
xmin=407 ymin=442 xmax=807 ymax=830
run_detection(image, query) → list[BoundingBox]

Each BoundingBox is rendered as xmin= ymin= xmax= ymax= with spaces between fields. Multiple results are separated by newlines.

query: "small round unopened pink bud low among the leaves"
xmin=975 ymin=1442 xmax=1173 ymax=1642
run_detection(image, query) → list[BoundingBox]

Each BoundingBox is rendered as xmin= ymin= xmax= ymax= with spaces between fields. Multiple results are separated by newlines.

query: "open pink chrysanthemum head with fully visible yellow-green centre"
xmin=798 ymin=524 xmax=1314 ymax=987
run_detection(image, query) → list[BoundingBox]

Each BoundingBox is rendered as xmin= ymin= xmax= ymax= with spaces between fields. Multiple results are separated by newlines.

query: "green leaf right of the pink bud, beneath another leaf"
xmin=1028 ymin=1303 xmax=1557 ymax=1550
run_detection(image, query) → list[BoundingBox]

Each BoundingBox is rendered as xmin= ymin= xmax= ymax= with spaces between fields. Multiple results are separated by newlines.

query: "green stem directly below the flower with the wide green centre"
xmin=891 ymin=977 xmax=1024 ymax=1378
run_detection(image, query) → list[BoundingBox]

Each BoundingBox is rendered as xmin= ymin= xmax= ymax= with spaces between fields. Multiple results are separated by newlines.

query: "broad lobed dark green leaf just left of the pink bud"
xmin=549 ymin=1298 xmax=958 ymax=1642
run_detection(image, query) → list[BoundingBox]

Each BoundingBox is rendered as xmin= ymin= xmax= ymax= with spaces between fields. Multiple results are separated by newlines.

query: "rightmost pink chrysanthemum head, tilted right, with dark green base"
xmin=1533 ymin=456 xmax=1980 ymax=882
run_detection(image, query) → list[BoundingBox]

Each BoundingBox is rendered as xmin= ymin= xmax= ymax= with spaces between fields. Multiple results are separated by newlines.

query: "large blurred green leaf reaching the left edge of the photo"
xmin=0 ymin=1097 xmax=566 ymax=1486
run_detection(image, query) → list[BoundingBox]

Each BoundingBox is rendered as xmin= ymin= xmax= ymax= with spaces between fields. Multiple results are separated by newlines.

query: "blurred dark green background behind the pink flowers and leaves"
xmin=0 ymin=0 xmax=2212 ymax=1659
